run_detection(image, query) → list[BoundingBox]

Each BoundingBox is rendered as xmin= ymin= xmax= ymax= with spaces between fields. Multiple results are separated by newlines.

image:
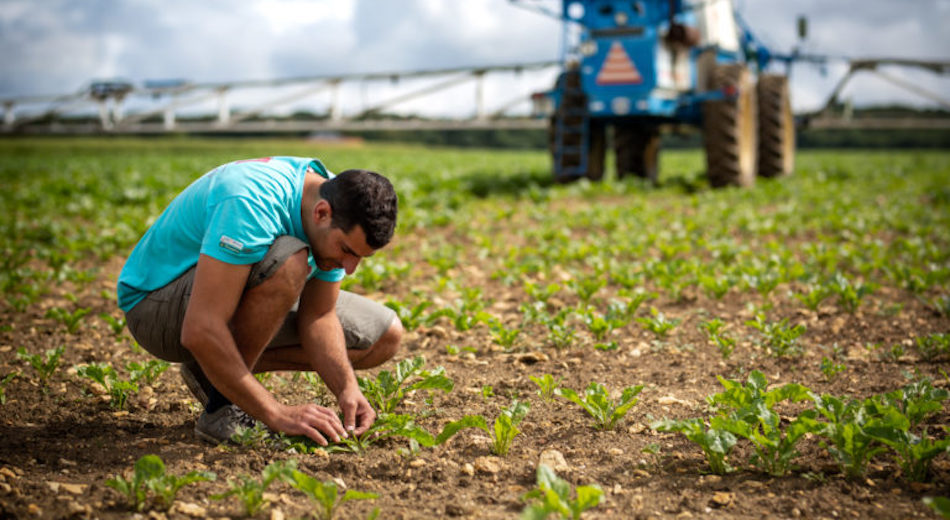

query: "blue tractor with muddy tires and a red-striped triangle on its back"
xmin=524 ymin=0 xmax=803 ymax=187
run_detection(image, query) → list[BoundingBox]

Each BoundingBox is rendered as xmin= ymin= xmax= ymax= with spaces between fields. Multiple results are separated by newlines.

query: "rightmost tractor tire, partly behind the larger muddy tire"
xmin=756 ymin=75 xmax=795 ymax=177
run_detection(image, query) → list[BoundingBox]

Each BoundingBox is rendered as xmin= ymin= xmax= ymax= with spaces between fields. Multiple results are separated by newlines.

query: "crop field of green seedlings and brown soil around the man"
xmin=0 ymin=139 xmax=950 ymax=519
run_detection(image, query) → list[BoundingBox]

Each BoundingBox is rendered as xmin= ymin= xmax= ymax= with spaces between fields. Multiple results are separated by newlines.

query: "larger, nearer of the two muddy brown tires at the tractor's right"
xmin=703 ymin=63 xmax=758 ymax=188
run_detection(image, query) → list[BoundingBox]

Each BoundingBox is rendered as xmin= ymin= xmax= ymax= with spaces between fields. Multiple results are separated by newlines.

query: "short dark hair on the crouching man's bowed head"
xmin=320 ymin=170 xmax=398 ymax=249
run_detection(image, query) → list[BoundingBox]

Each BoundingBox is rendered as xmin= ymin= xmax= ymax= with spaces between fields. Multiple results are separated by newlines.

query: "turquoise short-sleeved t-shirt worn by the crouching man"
xmin=117 ymin=157 xmax=345 ymax=311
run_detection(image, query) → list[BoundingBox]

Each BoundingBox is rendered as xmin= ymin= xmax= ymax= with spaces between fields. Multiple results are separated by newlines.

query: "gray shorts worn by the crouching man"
xmin=125 ymin=236 xmax=396 ymax=363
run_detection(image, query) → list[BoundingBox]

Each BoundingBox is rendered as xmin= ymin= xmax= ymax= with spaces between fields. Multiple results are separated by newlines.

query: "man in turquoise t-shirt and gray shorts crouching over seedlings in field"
xmin=117 ymin=157 xmax=402 ymax=445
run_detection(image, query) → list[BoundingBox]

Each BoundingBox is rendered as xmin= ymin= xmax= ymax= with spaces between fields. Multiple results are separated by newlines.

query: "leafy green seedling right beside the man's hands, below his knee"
xmin=358 ymin=356 xmax=455 ymax=413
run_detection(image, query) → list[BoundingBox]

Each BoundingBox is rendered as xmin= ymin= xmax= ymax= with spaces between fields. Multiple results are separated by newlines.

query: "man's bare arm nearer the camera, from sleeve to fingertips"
xmin=181 ymin=255 xmax=345 ymax=445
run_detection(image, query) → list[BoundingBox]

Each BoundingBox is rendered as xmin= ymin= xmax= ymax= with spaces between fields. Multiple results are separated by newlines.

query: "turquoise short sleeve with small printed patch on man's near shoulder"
xmin=201 ymin=197 xmax=279 ymax=265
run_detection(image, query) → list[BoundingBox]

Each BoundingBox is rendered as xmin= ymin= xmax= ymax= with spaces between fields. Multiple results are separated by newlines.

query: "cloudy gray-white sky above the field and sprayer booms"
xmin=0 ymin=0 xmax=950 ymax=118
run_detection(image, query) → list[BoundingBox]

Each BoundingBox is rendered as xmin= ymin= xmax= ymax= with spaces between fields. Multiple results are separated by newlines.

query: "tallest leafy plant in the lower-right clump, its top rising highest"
xmin=707 ymin=370 xmax=817 ymax=476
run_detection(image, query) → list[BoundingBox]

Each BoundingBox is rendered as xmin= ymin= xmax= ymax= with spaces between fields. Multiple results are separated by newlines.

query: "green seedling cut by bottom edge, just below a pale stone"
xmin=521 ymin=464 xmax=604 ymax=520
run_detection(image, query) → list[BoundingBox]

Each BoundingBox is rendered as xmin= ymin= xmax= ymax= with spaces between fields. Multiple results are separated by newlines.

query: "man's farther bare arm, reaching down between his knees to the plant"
xmin=297 ymin=279 xmax=376 ymax=435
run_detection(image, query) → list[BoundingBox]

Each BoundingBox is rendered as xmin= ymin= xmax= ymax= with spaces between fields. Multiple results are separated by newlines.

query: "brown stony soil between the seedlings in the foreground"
xmin=0 ymin=229 xmax=950 ymax=519
